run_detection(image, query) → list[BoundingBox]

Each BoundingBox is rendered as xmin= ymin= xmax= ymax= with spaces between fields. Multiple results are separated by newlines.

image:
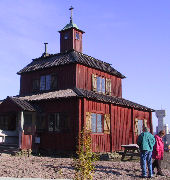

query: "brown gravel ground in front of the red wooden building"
xmin=0 ymin=153 xmax=170 ymax=180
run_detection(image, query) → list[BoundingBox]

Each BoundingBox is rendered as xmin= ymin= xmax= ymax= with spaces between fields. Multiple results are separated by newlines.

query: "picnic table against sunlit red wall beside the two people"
xmin=121 ymin=144 xmax=140 ymax=160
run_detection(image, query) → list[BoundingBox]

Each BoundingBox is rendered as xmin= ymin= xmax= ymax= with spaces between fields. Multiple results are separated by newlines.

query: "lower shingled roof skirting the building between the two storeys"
xmin=13 ymin=88 xmax=155 ymax=111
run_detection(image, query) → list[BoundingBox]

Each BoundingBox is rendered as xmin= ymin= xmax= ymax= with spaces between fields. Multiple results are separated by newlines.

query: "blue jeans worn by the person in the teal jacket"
xmin=140 ymin=151 xmax=153 ymax=176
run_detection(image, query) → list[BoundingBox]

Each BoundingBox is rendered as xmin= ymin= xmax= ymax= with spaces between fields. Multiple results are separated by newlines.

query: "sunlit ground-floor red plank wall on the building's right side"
xmin=79 ymin=99 xmax=152 ymax=152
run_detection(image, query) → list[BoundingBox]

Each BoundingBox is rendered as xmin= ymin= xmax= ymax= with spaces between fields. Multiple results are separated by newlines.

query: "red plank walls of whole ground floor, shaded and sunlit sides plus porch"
xmin=0 ymin=98 xmax=153 ymax=152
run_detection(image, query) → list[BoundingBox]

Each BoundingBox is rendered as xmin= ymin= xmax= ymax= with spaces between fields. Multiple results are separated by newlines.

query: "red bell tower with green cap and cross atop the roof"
xmin=59 ymin=6 xmax=84 ymax=53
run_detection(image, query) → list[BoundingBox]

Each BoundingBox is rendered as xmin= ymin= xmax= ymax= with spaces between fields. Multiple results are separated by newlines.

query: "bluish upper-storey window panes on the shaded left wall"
xmin=40 ymin=75 xmax=51 ymax=91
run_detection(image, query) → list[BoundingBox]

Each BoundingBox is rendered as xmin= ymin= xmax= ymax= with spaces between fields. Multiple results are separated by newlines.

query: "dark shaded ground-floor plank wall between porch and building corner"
xmin=32 ymin=99 xmax=78 ymax=151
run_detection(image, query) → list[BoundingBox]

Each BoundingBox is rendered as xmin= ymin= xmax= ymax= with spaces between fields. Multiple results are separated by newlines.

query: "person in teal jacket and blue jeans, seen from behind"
xmin=137 ymin=127 xmax=155 ymax=178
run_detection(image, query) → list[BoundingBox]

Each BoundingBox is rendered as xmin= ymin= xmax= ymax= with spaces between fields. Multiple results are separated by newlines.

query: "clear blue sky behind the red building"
xmin=0 ymin=0 xmax=170 ymax=131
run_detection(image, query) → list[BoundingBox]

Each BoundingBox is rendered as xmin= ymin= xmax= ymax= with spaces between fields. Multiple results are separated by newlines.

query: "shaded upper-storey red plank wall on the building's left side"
xmin=20 ymin=64 xmax=76 ymax=95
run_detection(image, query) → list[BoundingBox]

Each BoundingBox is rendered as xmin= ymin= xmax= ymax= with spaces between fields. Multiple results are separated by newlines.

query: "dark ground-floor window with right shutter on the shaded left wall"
xmin=48 ymin=113 xmax=69 ymax=132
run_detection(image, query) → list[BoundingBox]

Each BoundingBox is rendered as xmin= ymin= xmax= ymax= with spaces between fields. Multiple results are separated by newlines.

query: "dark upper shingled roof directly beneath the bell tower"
xmin=17 ymin=50 xmax=125 ymax=78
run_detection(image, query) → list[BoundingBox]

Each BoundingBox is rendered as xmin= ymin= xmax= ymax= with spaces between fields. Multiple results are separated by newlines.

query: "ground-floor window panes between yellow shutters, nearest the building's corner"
xmin=91 ymin=113 xmax=103 ymax=133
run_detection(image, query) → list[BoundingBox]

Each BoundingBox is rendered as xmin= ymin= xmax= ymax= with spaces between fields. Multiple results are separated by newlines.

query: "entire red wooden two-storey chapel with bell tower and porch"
xmin=0 ymin=7 xmax=154 ymax=152
